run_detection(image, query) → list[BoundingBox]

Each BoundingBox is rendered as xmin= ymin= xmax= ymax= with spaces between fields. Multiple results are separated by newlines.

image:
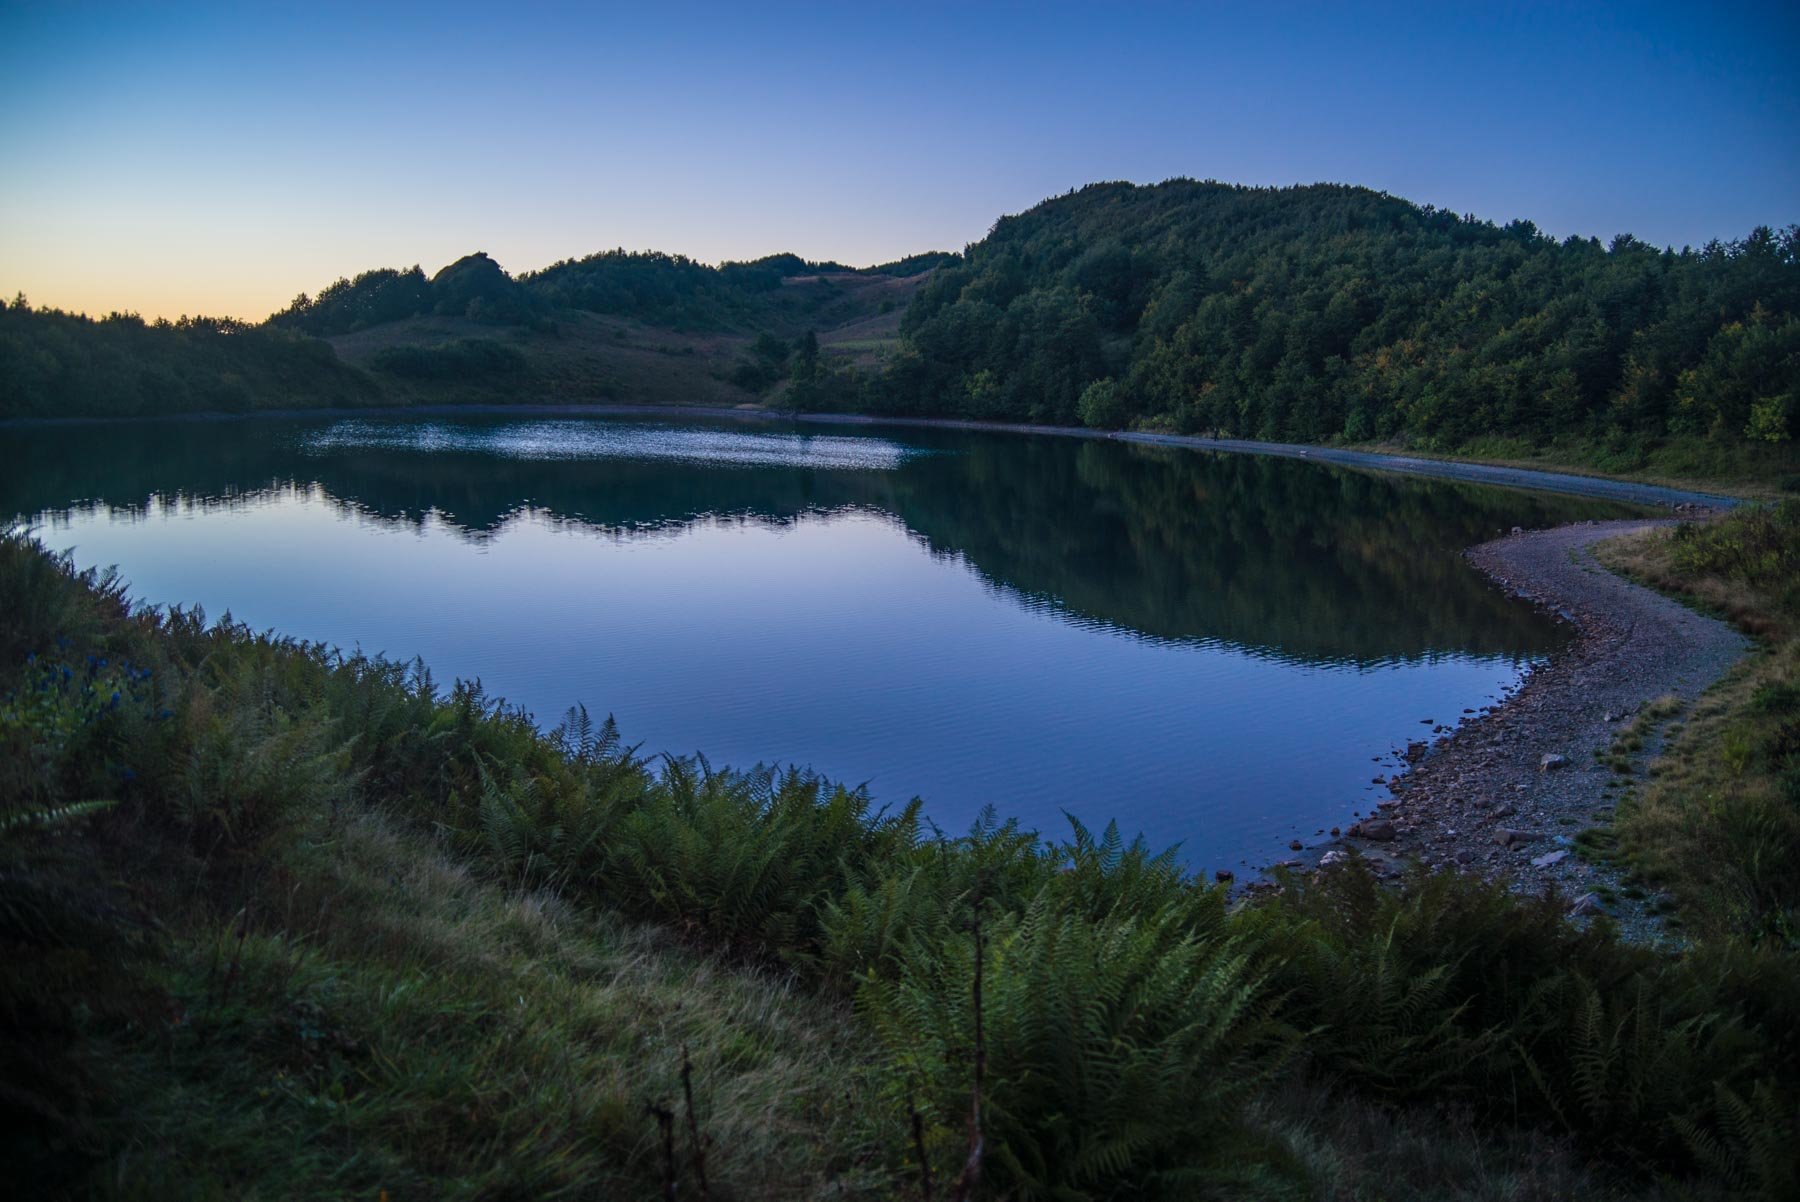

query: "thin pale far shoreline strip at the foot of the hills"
xmin=0 ymin=403 xmax=1741 ymax=509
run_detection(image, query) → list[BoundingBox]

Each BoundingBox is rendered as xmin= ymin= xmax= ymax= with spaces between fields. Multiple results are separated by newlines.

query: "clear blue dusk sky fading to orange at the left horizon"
xmin=0 ymin=0 xmax=1800 ymax=318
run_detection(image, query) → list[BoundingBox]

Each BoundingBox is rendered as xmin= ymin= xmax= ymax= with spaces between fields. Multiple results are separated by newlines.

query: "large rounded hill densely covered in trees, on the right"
xmin=856 ymin=180 xmax=1800 ymax=448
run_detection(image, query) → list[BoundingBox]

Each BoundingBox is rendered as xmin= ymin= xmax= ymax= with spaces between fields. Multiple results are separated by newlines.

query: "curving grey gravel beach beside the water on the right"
xmin=1346 ymin=522 xmax=1750 ymax=937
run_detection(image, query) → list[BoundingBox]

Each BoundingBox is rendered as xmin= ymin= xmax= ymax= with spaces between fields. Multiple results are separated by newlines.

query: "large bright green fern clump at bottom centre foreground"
xmin=857 ymin=885 xmax=1282 ymax=1198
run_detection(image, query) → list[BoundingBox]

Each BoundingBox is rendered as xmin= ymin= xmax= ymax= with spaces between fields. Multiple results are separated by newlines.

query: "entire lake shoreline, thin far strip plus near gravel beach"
xmin=0 ymin=405 xmax=1751 ymax=939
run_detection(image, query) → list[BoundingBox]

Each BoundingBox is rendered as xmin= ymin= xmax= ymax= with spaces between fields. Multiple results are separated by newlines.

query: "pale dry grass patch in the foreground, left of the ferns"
xmin=87 ymin=815 xmax=886 ymax=1198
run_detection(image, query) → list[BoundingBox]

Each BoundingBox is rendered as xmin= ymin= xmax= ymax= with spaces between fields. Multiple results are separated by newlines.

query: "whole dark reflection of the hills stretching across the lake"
xmin=0 ymin=423 xmax=1648 ymax=662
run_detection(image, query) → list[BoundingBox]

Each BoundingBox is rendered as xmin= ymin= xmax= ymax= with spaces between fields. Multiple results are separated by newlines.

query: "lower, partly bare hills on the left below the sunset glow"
xmin=0 ymin=250 xmax=956 ymax=419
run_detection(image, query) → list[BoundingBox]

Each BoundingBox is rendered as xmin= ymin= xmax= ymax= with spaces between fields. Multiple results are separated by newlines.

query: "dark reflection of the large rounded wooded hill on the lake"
xmin=871 ymin=439 xmax=1618 ymax=662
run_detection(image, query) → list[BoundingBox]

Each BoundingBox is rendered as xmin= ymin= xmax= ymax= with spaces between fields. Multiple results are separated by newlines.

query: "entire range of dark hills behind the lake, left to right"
xmin=0 ymin=180 xmax=1800 ymax=480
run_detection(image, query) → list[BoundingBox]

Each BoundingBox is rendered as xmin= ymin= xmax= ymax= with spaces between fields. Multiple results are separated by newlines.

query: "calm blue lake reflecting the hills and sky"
xmin=0 ymin=414 xmax=1633 ymax=873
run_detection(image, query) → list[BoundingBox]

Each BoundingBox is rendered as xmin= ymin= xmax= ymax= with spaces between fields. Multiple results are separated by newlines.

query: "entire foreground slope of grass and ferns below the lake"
xmin=0 ymin=540 xmax=1795 ymax=1198
